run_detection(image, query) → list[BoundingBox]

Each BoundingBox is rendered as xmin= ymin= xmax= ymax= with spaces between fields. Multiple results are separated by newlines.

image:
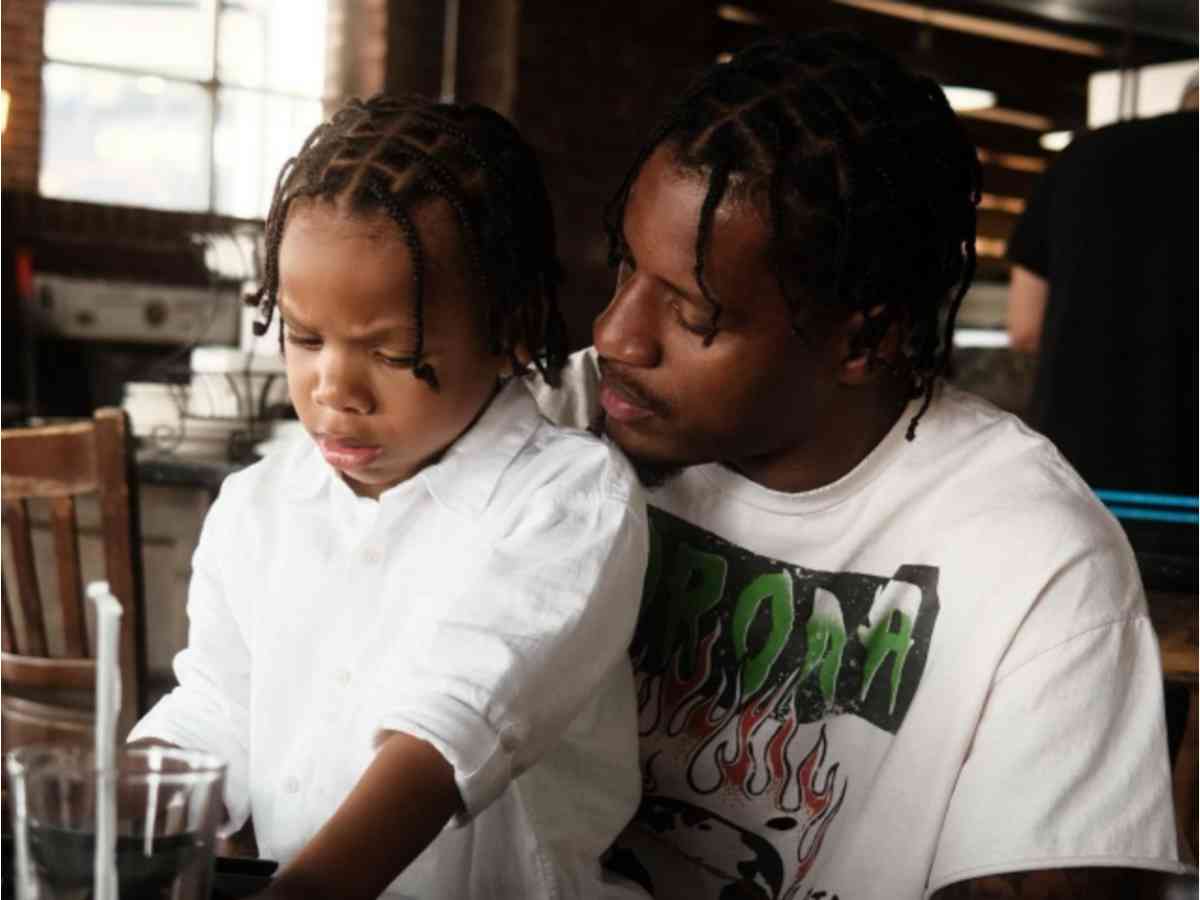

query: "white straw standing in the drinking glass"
xmin=88 ymin=581 xmax=121 ymax=900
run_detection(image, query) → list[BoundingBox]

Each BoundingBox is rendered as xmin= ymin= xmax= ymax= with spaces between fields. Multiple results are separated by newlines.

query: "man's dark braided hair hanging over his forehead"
xmin=605 ymin=32 xmax=980 ymax=440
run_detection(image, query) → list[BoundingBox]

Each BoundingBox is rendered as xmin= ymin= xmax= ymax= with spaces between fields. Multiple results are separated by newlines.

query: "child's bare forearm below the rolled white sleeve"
xmin=259 ymin=732 xmax=462 ymax=900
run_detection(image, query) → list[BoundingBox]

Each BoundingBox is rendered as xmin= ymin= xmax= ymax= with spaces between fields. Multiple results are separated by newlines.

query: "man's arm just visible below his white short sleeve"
xmin=932 ymin=868 xmax=1163 ymax=900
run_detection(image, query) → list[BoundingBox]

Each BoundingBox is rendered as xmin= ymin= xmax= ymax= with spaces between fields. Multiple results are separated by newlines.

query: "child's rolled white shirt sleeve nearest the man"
xmin=376 ymin=448 xmax=648 ymax=824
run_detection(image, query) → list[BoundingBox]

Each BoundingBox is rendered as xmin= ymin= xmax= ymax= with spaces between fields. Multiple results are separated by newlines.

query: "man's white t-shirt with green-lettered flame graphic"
xmin=533 ymin=352 xmax=1184 ymax=900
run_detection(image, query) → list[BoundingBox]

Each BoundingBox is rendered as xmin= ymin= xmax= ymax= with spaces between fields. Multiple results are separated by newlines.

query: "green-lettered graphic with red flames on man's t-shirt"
xmin=613 ymin=508 xmax=938 ymax=900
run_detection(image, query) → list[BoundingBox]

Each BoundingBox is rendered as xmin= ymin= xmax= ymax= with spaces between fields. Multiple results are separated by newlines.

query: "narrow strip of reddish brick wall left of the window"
xmin=0 ymin=0 xmax=46 ymax=191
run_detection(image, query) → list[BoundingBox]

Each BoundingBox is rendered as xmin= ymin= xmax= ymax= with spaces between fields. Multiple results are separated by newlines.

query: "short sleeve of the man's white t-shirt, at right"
xmin=929 ymin=614 xmax=1184 ymax=893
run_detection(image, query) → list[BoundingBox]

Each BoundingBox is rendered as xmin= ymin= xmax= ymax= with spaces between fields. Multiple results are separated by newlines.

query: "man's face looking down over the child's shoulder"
xmin=593 ymin=146 xmax=841 ymax=490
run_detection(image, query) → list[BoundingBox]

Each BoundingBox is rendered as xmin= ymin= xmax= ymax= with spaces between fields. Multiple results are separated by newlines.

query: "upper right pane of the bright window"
xmin=217 ymin=0 xmax=325 ymax=97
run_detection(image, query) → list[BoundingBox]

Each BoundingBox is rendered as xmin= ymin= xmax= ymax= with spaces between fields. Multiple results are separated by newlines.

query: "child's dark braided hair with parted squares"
xmin=247 ymin=95 xmax=566 ymax=388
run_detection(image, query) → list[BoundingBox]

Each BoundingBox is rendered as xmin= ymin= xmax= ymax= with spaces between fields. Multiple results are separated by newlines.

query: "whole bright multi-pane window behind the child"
xmin=38 ymin=0 xmax=326 ymax=218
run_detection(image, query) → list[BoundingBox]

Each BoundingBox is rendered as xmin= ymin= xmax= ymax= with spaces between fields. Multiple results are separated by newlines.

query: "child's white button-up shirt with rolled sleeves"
xmin=131 ymin=383 xmax=648 ymax=900
